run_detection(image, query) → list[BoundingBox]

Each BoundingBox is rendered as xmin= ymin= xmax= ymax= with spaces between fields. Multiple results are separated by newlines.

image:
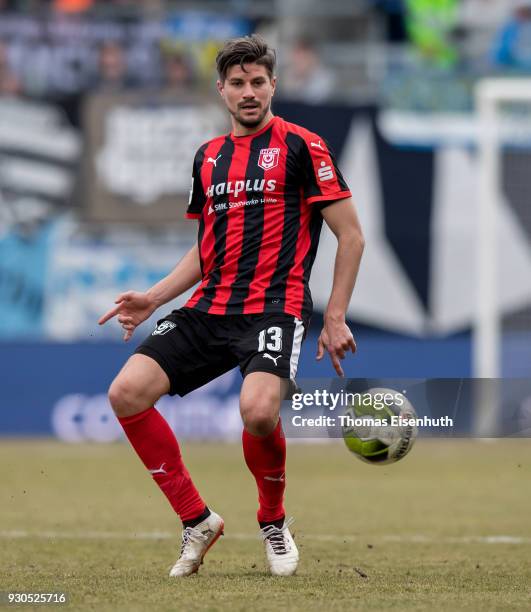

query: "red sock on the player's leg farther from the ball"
xmin=118 ymin=408 xmax=205 ymax=521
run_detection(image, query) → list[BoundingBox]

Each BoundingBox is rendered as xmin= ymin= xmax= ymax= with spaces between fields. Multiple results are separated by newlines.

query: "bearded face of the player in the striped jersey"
xmin=217 ymin=63 xmax=276 ymax=128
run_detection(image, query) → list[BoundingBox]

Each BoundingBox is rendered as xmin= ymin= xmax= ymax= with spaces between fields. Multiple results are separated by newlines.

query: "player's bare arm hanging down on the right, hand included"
xmin=317 ymin=197 xmax=364 ymax=376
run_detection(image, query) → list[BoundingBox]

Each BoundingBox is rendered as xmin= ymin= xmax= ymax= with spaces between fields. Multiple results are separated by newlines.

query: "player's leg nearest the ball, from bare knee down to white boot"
xmin=240 ymin=372 xmax=299 ymax=576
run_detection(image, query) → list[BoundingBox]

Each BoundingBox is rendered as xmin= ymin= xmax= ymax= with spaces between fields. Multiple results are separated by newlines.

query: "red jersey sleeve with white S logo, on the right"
xmin=301 ymin=136 xmax=352 ymax=205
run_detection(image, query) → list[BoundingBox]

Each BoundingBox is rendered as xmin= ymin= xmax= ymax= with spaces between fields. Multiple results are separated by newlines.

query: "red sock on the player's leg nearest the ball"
xmin=242 ymin=419 xmax=286 ymax=523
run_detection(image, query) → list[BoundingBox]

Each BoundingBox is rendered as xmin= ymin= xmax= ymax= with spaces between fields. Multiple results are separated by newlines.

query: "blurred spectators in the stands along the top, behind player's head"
xmin=0 ymin=0 xmax=531 ymax=113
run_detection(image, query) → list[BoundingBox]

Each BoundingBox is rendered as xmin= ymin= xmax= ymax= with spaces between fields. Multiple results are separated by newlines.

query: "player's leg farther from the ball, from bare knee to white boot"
xmin=109 ymin=354 xmax=223 ymax=576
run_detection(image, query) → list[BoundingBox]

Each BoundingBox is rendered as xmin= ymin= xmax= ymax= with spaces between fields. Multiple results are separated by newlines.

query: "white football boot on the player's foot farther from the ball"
xmin=170 ymin=510 xmax=224 ymax=578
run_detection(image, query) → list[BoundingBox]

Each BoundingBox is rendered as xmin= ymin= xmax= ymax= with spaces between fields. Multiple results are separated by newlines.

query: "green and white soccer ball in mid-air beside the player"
xmin=342 ymin=388 xmax=418 ymax=465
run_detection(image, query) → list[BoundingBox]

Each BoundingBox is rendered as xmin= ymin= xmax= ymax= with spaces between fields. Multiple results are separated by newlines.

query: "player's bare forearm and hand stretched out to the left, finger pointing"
xmin=98 ymin=244 xmax=201 ymax=342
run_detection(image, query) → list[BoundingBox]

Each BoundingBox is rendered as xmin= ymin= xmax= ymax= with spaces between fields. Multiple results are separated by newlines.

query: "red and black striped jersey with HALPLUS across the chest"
xmin=186 ymin=117 xmax=351 ymax=319
